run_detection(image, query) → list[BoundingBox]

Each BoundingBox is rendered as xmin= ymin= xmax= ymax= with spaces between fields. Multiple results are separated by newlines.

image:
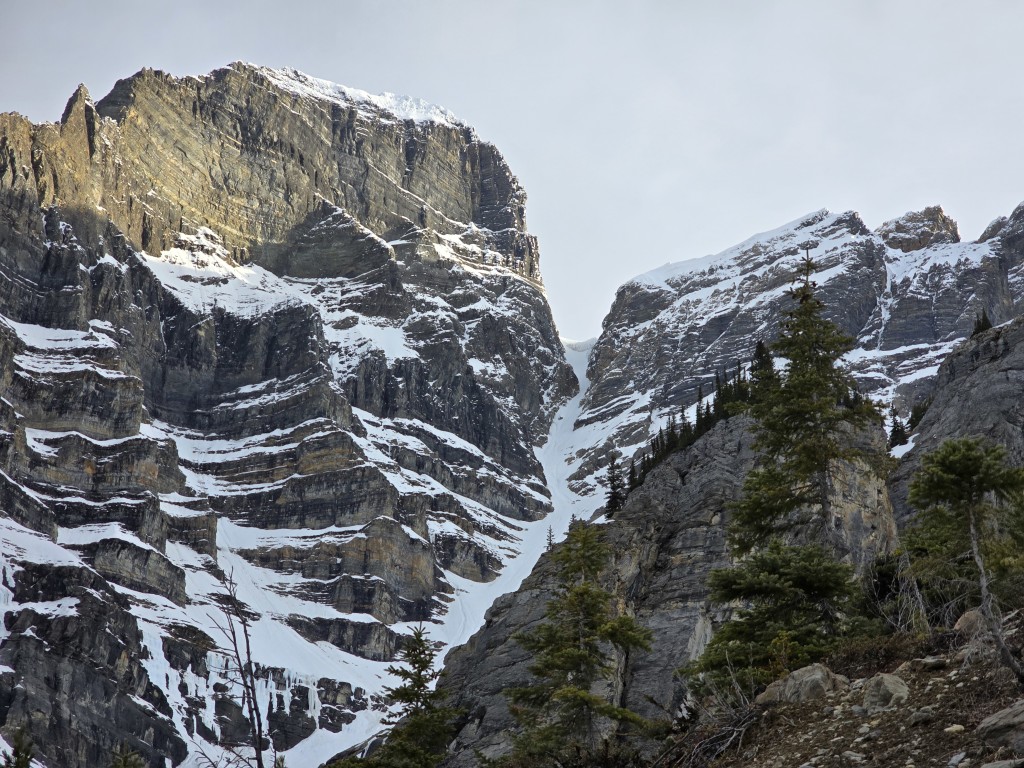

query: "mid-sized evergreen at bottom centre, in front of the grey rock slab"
xmin=506 ymin=523 xmax=650 ymax=761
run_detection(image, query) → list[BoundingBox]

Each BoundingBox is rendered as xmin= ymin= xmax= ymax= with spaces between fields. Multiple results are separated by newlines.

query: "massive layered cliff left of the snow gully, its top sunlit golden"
xmin=0 ymin=63 xmax=577 ymax=767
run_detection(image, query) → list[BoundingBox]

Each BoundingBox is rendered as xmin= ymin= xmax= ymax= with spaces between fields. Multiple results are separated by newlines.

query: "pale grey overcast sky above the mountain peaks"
xmin=0 ymin=0 xmax=1024 ymax=339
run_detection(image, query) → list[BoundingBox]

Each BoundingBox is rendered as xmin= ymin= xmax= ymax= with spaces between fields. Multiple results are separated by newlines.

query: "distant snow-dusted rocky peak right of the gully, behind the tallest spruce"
xmin=574 ymin=207 xmax=1024 ymax=492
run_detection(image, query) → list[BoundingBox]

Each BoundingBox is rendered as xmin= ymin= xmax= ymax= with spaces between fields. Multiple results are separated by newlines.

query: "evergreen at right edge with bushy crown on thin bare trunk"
xmin=909 ymin=439 xmax=1024 ymax=685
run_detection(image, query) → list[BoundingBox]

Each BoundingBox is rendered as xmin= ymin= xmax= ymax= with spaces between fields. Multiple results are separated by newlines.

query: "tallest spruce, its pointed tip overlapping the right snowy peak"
xmin=730 ymin=259 xmax=879 ymax=554
